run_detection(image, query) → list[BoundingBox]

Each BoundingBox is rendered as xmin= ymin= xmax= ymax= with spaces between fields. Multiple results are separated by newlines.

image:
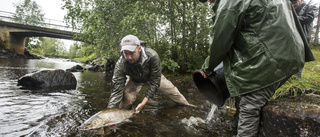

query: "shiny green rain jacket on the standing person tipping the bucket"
xmin=201 ymin=0 xmax=315 ymax=96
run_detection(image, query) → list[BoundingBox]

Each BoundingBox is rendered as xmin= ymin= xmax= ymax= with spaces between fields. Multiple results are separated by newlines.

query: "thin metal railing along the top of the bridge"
xmin=0 ymin=10 xmax=72 ymax=31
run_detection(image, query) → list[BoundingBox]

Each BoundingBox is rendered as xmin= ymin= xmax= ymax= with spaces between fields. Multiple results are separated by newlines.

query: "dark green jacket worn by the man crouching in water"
xmin=108 ymin=47 xmax=161 ymax=108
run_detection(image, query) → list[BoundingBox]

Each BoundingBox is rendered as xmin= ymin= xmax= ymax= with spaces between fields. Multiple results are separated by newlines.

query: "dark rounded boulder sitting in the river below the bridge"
xmin=18 ymin=69 xmax=77 ymax=89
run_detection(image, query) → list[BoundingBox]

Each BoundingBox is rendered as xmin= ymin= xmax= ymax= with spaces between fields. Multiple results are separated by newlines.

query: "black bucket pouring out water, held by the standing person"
xmin=193 ymin=64 xmax=230 ymax=107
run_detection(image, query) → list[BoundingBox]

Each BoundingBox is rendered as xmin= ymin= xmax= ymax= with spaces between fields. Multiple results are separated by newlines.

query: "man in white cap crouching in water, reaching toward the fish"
xmin=108 ymin=35 xmax=195 ymax=113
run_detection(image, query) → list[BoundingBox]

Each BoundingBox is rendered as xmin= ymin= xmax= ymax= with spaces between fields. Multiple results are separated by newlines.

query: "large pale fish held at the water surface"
xmin=79 ymin=108 xmax=135 ymax=130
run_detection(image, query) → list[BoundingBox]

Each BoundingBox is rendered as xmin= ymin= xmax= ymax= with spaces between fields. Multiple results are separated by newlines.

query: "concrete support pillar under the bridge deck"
xmin=9 ymin=33 xmax=26 ymax=55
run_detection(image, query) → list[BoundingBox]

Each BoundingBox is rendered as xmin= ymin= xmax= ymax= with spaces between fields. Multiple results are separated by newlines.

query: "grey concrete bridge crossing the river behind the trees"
xmin=0 ymin=20 xmax=77 ymax=54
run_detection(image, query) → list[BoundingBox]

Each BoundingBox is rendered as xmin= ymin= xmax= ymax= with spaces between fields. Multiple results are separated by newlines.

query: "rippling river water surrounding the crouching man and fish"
xmin=0 ymin=59 xmax=235 ymax=137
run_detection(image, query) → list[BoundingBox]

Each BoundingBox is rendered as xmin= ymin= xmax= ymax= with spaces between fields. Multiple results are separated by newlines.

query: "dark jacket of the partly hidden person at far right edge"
xmin=295 ymin=2 xmax=317 ymax=43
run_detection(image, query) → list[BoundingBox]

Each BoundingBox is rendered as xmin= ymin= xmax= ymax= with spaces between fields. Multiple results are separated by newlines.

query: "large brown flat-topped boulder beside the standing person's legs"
xmin=259 ymin=94 xmax=320 ymax=137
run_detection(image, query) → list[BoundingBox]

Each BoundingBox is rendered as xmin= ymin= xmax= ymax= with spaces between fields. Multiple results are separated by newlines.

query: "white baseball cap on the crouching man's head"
xmin=120 ymin=35 xmax=140 ymax=52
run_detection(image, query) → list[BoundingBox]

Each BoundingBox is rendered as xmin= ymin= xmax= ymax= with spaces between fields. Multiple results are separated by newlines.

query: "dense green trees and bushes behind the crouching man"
xmin=63 ymin=0 xmax=212 ymax=73
